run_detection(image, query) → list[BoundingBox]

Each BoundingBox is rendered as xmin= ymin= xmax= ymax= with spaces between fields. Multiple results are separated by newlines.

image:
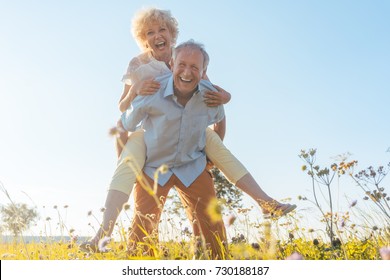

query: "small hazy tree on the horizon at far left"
xmin=0 ymin=203 xmax=38 ymax=237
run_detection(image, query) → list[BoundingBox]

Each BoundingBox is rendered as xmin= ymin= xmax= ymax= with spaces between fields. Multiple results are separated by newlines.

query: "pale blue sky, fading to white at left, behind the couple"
xmin=0 ymin=0 xmax=390 ymax=238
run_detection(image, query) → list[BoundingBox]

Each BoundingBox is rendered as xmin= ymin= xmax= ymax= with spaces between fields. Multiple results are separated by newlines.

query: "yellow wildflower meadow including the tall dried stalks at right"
xmin=0 ymin=149 xmax=390 ymax=260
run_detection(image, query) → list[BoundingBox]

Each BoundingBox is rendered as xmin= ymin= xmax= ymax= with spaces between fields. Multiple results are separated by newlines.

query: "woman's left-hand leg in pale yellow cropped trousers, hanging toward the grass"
xmin=81 ymin=130 xmax=146 ymax=251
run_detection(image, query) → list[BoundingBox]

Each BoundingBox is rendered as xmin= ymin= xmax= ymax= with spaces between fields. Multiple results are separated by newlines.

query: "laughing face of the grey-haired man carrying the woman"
xmin=171 ymin=47 xmax=203 ymax=95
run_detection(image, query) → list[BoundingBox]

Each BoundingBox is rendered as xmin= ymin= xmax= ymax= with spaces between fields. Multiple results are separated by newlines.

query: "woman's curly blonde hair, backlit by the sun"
xmin=131 ymin=8 xmax=179 ymax=51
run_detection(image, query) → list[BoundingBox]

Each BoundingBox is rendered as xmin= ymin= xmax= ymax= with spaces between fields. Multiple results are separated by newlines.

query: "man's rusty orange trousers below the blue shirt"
xmin=129 ymin=167 xmax=227 ymax=259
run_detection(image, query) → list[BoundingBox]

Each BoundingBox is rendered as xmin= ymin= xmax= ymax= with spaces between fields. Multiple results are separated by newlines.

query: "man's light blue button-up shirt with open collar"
xmin=122 ymin=74 xmax=225 ymax=187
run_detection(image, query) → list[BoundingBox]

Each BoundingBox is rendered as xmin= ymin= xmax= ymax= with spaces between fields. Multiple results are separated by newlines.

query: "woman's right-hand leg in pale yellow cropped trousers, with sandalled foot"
xmin=206 ymin=128 xmax=295 ymax=216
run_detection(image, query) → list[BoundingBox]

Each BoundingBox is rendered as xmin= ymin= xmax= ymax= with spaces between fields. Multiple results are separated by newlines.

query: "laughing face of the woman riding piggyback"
xmin=145 ymin=22 xmax=172 ymax=61
